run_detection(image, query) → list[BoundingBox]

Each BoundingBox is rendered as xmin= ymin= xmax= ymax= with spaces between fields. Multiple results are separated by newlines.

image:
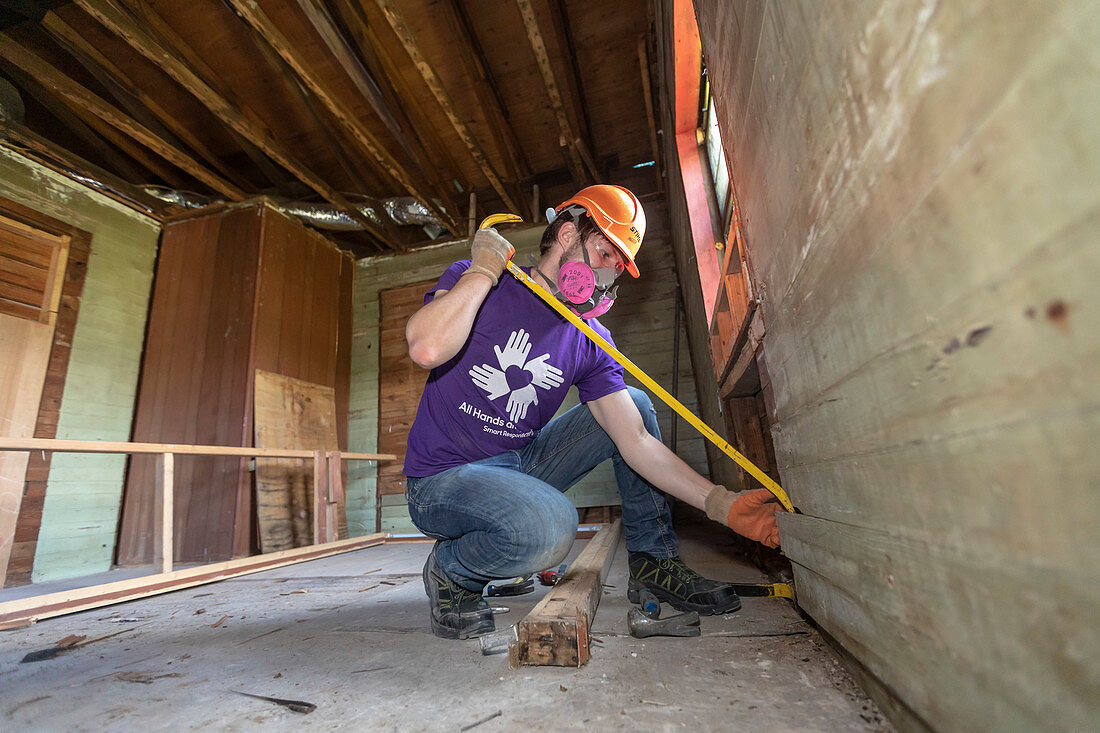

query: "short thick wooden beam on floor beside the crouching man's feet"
xmin=508 ymin=521 xmax=623 ymax=667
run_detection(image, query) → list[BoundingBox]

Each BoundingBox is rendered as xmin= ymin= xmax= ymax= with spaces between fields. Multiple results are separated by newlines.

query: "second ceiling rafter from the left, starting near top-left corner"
xmin=42 ymin=10 xmax=251 ymax=190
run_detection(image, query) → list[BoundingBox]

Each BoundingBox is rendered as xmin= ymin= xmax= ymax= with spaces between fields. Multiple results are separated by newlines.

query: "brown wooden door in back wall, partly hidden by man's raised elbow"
xmin=378 ymin=280 xmax=436 ymax=517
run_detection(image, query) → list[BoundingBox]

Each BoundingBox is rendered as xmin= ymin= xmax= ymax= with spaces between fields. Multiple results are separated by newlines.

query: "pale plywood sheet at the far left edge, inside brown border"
xmin=0 ymin=314 xmax=54 ymax=586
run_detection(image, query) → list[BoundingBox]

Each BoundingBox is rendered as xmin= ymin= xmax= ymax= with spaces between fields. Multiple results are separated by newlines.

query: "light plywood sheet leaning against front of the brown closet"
xmin=255 ymin=369 xmax=348 ymax=553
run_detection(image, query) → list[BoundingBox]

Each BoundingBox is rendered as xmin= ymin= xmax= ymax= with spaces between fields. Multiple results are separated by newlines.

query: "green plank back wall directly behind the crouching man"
xmin=348 ymin=211 xmax=706 ymax=535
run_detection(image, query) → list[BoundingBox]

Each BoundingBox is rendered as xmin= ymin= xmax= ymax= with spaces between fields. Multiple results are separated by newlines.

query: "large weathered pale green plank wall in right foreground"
xmin=695 ymin=0 xmax=1100 ymax=730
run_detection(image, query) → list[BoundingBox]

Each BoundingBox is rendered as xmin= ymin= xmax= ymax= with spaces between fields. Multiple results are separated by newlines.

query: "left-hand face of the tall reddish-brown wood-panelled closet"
xmin=118 ymin=207 xmax=262 ymax=565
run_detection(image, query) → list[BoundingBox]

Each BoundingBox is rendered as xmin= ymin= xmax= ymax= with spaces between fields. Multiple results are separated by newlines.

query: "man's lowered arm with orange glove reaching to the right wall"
xmin=589 ymin=390 xmax=782 ymax=547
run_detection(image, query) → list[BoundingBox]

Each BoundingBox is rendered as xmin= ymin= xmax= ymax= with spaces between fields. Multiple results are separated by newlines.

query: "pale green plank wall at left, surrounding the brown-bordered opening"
xmin=0 ymin=149 xmax=161 ymax=582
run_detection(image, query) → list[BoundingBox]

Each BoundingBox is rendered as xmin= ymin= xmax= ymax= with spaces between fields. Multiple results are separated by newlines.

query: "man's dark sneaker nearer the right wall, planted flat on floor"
xmin=626 ymin=553 xmax=741 ymax=615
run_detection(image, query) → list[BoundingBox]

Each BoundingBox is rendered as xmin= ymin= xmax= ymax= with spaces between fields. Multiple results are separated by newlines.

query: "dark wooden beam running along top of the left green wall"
xmin=0 ymin=119 xmax=182 ymax=215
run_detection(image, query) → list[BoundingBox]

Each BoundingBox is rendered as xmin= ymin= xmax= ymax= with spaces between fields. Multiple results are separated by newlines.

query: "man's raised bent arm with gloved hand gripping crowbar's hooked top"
xmin=405 ymin=229 xmax=512 ymax=369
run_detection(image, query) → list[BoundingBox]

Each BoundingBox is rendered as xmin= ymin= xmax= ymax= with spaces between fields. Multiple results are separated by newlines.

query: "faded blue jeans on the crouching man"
xmin=406 ymin=387 xmax=678 ymax=592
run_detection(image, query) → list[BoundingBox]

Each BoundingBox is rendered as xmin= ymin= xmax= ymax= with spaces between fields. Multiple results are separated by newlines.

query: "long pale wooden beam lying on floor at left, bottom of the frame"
xmin=0 ymin=528 xmax=386 ymax=628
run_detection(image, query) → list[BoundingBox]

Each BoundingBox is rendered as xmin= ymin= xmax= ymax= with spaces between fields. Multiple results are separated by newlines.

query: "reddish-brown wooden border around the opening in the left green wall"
xmin=0 ymin=199 xmax=91 ymax=586
